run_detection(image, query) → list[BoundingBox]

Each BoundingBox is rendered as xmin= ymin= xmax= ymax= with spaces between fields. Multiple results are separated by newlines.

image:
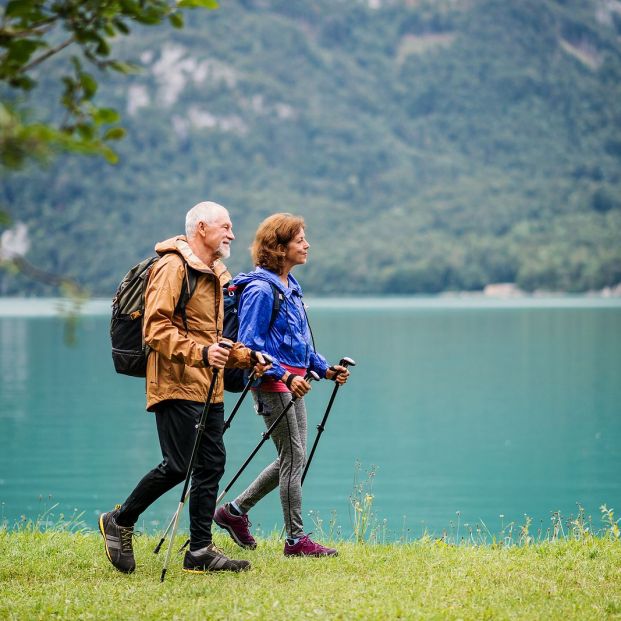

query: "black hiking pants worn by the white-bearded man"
xmin=116 ymin=399 xmax=226 ymax=551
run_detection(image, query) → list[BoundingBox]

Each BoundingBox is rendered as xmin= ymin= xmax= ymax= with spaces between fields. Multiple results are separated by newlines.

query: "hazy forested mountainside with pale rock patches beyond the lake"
xmin=0 ymin=0 xmax=621 ymax=295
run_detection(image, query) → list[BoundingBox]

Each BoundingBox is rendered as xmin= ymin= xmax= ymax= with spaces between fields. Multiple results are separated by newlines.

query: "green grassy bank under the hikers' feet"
xmin=0 ymin=529 xmax=621 ymax=621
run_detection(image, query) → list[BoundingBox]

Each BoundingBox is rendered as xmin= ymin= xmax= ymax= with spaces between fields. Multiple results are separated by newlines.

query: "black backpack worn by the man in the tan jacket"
xmin=110 ymin=257 xmax=198 ymax=377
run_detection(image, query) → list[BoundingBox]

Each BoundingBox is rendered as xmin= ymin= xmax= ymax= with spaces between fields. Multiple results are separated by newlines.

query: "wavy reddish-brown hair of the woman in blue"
xmin=250 ymin=213 xmax=304 ymax=274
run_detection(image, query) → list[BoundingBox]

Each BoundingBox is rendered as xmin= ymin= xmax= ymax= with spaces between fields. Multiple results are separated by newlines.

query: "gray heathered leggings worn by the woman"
xmin=235 ymin=392 xmax=306 ymax=537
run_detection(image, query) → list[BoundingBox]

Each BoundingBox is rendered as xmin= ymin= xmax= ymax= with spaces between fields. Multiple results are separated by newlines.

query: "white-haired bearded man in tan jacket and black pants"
xmin=99 ymin=202 xmax=269 ymax=573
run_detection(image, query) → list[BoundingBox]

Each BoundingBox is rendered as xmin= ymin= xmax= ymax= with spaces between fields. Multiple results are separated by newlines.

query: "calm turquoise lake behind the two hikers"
xmin=0 ymin=297 xmax=621 ymax=540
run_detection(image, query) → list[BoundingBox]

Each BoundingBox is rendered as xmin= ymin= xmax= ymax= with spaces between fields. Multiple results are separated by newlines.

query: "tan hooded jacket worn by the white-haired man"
xmin=144 ymin=235 xmax=252 ymax=410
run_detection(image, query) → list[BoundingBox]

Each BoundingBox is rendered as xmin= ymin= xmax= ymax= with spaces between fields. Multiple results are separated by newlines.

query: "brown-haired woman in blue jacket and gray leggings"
xmin=214 ymin=213 xmax=349 ymax=556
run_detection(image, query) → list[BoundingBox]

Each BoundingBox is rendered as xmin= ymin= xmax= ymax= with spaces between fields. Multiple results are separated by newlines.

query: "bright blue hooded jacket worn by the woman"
xmin=233 ymin=267 xmax=329 ymax=379
